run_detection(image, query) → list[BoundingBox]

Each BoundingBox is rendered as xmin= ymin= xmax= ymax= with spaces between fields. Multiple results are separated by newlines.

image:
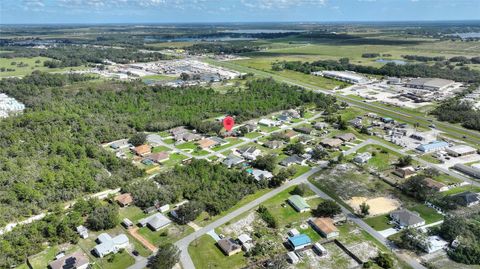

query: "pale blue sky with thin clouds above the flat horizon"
xmin=0 ymin=0 xmax=480 ymax=24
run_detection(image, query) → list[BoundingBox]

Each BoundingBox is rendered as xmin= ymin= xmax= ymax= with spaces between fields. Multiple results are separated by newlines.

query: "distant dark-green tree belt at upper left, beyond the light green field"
xmin=0 ymin=46 xmax=171 ymax=68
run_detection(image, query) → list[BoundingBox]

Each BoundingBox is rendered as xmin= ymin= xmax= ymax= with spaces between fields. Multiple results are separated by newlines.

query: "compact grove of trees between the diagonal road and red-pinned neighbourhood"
xmin=155 ymin=160 xmax=266 ymax=215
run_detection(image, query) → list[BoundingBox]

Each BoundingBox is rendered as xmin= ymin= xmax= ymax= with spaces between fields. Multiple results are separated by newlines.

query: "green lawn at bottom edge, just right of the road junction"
xmin=188 ymin=232 xmax=247 ymax=269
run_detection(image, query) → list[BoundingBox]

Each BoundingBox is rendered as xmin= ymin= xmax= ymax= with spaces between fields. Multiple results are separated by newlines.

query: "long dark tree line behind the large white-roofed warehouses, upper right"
xmin=272 ymin=58 xmax=480 ymax=83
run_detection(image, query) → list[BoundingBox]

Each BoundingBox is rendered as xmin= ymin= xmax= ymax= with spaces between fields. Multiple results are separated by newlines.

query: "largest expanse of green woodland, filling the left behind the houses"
xmin=0 ymin=72 xmax=336 ymax=224
